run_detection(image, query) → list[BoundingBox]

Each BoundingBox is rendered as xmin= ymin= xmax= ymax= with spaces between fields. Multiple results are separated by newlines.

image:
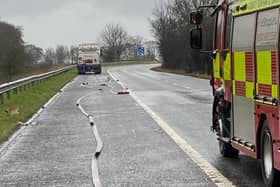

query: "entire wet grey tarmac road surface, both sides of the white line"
xmin=0 ymin=65 xmax=263 ymax=186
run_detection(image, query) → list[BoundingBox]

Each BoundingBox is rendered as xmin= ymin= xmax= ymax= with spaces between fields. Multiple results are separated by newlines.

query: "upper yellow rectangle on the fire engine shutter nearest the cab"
xmin=234 ymin=52 xmax=246 ymax=81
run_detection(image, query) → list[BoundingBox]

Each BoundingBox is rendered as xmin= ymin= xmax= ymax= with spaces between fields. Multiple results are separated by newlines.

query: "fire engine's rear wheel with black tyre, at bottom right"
xmin=260 ymin=121 xmax=280 ymax=187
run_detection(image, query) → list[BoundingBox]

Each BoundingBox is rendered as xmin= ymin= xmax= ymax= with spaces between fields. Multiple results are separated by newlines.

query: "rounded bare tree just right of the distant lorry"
xmin=101 ymin=23 xmax=127 ymax=61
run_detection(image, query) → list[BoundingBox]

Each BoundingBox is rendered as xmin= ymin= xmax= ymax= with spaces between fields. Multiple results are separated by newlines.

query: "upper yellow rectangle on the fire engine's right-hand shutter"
xmin=257 ymin=51 xmax=272 ymax=85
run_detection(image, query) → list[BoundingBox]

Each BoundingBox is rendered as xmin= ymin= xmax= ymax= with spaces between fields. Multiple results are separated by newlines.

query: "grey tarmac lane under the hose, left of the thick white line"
xmin=0 ymin=66 xmax=215 ymax=187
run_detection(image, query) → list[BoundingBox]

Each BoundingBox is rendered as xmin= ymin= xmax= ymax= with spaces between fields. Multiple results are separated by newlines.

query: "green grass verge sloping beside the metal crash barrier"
xmin=0 ymin=68 xmax=77 ymax=143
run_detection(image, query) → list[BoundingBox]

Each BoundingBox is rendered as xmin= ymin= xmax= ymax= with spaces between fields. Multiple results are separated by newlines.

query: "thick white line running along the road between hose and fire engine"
xmin=108 ymin=70 xmax=235 ymax=187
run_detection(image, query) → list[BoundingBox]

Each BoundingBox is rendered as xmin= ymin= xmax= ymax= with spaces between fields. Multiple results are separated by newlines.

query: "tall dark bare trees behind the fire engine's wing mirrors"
xmin=150 ymin=0 xmax=214 ymax=73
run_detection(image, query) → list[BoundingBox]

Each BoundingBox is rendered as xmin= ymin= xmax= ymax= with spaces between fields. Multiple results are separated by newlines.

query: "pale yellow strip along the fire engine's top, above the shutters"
xmin=232 ymin=0 xmax=280 ymax=16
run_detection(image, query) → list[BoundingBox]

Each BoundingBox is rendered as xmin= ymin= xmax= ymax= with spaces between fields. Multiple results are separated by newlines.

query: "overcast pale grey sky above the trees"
xmin=0 ymin=0 xmax=166 ymax=48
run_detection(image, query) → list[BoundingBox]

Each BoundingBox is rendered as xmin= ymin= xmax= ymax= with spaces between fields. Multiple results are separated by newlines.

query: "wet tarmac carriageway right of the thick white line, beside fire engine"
xmin=110 ymin=65 xmax=264 ymax=186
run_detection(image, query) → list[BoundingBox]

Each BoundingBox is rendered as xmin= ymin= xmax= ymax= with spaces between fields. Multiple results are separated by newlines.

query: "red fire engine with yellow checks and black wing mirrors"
xmin=190 ymin=0 xmax=280 ymax=186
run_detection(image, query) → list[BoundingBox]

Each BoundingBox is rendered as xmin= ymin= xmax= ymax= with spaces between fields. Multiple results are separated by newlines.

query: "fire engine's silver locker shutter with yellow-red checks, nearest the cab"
xmin=232 ymin=13 xmax=256 ymax=144
